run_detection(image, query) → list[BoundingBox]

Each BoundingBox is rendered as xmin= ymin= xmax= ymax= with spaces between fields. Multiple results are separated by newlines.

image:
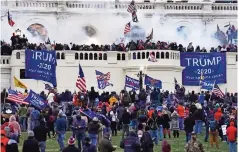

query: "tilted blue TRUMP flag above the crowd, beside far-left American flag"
xmin=24 ymin=90 xmax=47 ymax=109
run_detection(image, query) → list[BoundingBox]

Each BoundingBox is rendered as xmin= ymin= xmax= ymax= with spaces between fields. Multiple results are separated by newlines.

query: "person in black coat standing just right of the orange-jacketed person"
xmin=184 ymin=113 xmax=195 ymax=143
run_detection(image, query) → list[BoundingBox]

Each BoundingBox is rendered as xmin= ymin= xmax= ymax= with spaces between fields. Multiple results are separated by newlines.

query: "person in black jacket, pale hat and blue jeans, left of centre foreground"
xmin=88 ymin=117 xmax=101 ymax=146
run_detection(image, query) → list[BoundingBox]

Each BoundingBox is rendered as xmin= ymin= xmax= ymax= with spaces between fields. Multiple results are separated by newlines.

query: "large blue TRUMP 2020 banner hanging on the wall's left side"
xmin=25 ymin=50 xmax=57 ymax=87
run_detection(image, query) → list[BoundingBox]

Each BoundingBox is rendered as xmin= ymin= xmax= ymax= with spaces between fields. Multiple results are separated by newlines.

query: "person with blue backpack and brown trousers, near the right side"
xmin=209 ymin=119 xmax=219 ymax=148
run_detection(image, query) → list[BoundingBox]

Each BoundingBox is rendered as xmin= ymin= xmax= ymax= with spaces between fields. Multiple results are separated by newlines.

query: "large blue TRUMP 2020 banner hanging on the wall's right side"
xmin=180 ymin=52 xmax=226 ymax=86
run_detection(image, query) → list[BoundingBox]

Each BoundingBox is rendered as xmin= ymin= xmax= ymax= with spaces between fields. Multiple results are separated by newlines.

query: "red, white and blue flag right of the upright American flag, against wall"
xmin=95 ymin=70 xmax=113 ymax=89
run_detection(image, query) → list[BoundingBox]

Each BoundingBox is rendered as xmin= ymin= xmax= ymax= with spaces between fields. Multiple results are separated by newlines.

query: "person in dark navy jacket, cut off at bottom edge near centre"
xmin=120 ymin=132 xmax=140 ymax=152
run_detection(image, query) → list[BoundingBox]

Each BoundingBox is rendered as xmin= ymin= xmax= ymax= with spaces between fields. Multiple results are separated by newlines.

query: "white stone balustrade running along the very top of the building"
xmin=1 ymin=1 xmax=238 ymax=11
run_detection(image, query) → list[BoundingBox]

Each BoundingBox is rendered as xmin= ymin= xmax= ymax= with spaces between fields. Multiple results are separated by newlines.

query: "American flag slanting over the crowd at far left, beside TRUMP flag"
xmin=7 ymin=89 xmax=29 ymax=104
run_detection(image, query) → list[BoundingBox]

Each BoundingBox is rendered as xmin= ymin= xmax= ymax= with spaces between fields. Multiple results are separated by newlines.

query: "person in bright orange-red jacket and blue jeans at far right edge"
xmin=226 ymin=121 xmax=237 ymax=152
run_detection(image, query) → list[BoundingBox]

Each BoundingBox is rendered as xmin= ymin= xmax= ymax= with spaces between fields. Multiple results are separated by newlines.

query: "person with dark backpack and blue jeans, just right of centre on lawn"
xmin=147 ymin=113 xmax=159 ymax=145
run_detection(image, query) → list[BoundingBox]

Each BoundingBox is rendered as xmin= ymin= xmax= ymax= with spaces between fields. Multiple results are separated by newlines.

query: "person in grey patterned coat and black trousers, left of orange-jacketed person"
xmin=171 ymin=110 xmax=179 ymax=138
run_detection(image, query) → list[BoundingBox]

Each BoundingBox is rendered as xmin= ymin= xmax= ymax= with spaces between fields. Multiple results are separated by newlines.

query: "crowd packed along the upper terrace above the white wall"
xmin=1 ymin=33 xmax=237 ymax=55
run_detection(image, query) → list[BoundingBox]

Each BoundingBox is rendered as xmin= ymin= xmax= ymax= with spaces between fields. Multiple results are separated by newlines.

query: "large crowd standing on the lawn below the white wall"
xmin=1 ymin=87 xmax=237 ymax=152
